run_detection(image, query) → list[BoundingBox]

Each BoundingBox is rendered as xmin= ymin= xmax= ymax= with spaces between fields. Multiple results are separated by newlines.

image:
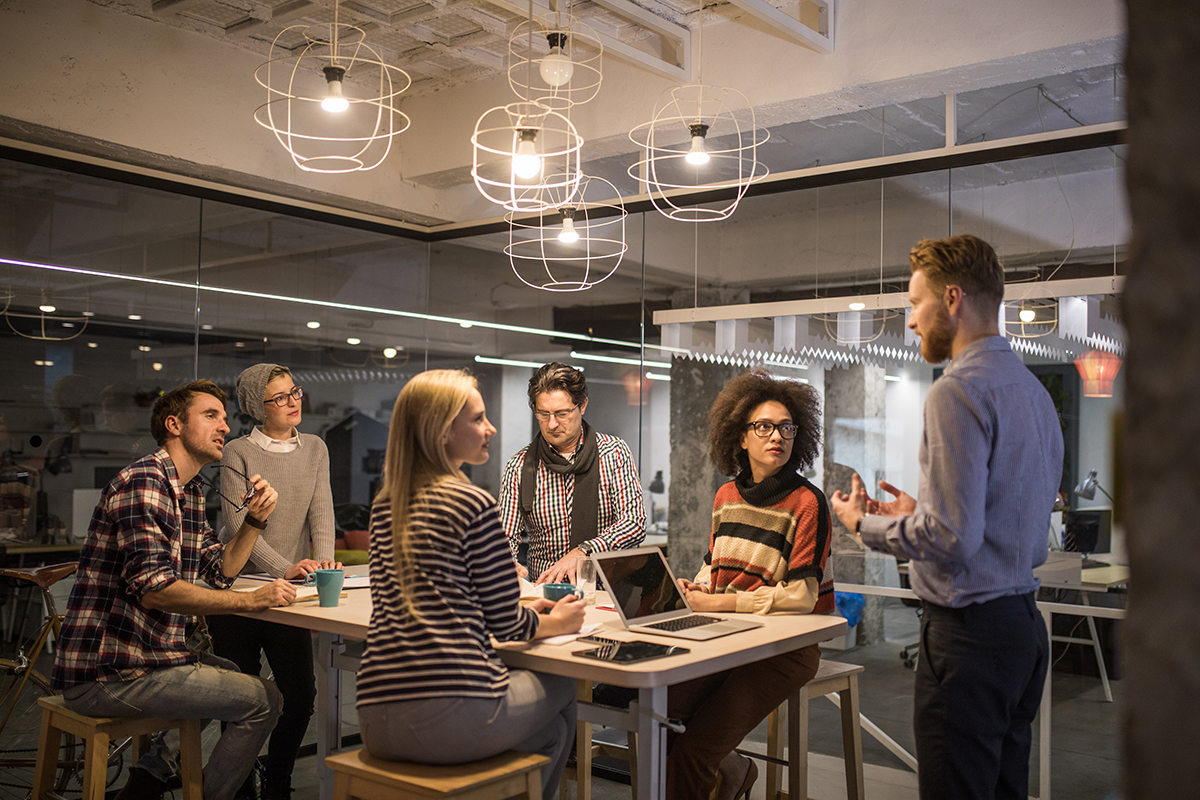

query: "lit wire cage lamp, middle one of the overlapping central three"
xmin=470 ymin=102 xmax=583 ymax=211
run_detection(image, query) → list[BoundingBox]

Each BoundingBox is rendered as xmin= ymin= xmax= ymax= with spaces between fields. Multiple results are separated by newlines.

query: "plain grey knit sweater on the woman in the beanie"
xmin=221 ymin=433 xmax=334 ymax=578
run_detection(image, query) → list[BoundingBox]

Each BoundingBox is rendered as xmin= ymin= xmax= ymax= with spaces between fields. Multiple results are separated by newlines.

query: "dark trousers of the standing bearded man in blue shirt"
xmin=913 ymin=594 xmax=1050 ymax=800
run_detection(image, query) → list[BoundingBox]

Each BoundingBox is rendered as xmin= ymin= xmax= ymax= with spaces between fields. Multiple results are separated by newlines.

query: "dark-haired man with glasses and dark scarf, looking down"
xmin=499 ymin=361 xmax=646 ymax=583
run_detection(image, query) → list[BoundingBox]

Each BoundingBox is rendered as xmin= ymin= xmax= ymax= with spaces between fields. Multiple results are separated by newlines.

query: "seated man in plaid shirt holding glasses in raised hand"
xmin=53 ymin=380 xmax=295 ymax=800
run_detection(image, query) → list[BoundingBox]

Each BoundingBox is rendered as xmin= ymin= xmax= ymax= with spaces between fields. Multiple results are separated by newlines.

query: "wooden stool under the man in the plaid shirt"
xmin=34 ymin=694 xmax=204 ymax=800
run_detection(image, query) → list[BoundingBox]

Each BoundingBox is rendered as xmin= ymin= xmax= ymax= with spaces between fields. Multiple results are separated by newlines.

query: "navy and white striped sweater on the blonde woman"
xmin=358 ymin=480 xmax=538 ymax=708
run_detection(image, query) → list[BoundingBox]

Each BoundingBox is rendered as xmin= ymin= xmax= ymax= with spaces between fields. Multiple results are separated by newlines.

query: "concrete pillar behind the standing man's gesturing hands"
xmin=824 ymin=363 xmax=887 ymax=644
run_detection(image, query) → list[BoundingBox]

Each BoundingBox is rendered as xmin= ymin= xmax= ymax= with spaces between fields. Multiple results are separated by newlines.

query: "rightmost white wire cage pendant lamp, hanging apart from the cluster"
xmin=629 ymin=84 xmax=770 ymax=222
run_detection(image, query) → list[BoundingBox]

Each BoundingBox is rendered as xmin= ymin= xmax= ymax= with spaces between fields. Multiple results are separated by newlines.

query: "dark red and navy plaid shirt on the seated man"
xmin=52 ymin=449 xmax=233 ymax=691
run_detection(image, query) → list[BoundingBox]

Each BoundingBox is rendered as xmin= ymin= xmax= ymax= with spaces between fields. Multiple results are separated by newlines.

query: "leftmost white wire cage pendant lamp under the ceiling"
xmin=254 ymin=2 xmax=413 ymax=173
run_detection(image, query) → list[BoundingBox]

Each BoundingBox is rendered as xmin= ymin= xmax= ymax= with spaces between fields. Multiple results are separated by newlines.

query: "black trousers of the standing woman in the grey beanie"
xmin=208 ymin=614 xmax=317 ymax=786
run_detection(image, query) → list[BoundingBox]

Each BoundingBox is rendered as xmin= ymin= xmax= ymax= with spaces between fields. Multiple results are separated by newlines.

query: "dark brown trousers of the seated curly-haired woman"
xmin=667 ymin=637 xmax=821 ymax=800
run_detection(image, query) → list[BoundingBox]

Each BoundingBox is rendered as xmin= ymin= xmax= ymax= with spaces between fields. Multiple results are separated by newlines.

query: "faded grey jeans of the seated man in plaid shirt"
xmin=62 ymin=652 xmax=282 ymax=800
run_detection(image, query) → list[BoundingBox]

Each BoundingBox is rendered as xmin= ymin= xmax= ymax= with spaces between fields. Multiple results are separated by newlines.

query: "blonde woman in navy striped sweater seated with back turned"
xmin=358 ymin=369 xmax=586 ymax=798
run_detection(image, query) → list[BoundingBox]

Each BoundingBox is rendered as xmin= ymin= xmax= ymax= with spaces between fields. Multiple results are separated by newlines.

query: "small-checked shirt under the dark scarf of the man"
xmin=499 ymin=432 xmax=646 ymax=581
